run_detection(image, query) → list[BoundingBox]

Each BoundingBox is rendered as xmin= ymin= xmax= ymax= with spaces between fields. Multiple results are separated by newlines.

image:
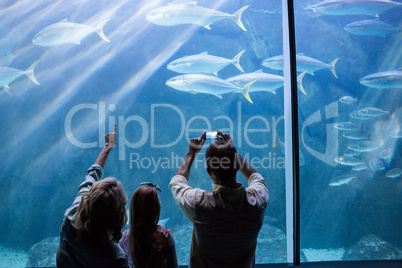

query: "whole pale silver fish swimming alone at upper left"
xmin=32 ymin=19 xmax=110 ymax=47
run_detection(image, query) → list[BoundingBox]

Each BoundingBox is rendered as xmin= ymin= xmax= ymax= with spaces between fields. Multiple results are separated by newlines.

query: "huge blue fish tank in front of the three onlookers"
xmin=0 ymin=0 xmax=402 ymax=267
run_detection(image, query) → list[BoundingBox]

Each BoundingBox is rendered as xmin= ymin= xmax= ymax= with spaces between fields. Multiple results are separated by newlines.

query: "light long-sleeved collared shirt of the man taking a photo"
xmin=169 ymin=173 xmax=269 ymax=268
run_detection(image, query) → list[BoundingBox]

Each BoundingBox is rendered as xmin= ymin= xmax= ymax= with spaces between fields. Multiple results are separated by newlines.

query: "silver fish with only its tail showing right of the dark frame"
xmin=226 ymin=70 xmax=307 ymax=95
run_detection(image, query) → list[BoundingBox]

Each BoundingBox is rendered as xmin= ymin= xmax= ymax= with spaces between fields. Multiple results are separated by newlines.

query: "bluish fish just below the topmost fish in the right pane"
xmin=343 ymin=20 xmax=401 ymax=37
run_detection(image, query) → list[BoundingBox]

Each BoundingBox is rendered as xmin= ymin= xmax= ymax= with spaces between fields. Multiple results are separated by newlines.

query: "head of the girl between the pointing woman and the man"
xmin=130 ymin=185 xmax=161 ymax=230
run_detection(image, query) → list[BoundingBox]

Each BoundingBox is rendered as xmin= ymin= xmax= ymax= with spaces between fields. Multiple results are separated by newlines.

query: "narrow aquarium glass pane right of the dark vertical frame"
xmin=295 ymin=0 xmax=402 ymax=261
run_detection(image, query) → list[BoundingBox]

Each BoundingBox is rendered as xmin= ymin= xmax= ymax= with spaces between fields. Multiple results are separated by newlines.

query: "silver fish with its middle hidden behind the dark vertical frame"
xmin=262 ymin=54 xmax=339 ymax=78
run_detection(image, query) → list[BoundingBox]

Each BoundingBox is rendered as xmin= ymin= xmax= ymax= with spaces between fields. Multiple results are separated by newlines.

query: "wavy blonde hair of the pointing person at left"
xmin=76 ymin=177 xmax=127 ymax=248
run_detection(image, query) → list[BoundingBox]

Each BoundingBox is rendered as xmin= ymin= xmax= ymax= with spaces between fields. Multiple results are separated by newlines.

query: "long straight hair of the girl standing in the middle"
xmin=129 ymin=185 xmax=161 ymax=268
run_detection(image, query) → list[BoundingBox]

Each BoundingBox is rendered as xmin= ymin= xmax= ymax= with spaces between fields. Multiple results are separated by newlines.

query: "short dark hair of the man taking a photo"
xmin=205 ymin=140 xmax=239 ymax=180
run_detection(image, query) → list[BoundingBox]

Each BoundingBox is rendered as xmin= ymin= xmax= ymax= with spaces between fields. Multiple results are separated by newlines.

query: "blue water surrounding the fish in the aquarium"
xmin=0 ymin=0 xmax=402 ymax=263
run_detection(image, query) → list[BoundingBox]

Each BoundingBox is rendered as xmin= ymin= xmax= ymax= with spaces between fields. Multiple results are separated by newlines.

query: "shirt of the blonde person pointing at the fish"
xmin=56 ymin=165 xmax=131 ymax=268
